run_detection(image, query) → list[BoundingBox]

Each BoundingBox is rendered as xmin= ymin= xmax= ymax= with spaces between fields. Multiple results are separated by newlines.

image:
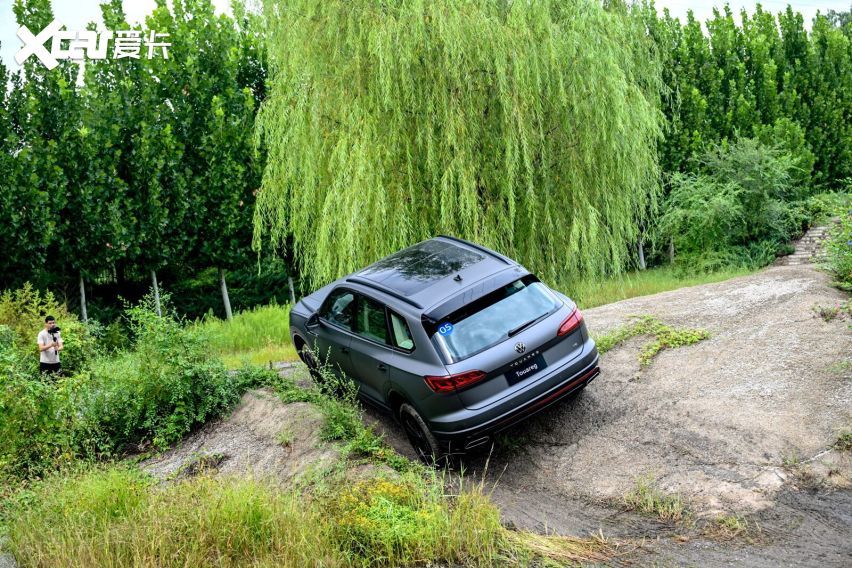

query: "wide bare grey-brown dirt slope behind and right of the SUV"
xmin=371 ymin=265 xmax=852 ymax=566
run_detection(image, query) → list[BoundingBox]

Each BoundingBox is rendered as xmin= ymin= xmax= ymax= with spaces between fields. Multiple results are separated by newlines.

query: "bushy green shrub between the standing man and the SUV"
xmin=75 ymin=296 xmax=276 ymax=453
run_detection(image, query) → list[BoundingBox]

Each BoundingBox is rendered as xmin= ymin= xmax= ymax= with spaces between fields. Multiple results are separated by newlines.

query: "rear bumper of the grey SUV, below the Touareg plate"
xmin=431 ymin=340 xmax=600 ymax=448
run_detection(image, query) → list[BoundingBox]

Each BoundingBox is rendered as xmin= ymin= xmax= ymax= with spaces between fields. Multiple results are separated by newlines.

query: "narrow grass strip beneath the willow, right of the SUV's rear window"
xmin=562 ymin=266 xmax=754 ymax=309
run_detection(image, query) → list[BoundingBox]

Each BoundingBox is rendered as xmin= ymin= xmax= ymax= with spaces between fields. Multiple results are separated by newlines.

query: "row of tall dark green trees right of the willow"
xmin=643 ymin=3 xmax=852 ymax=188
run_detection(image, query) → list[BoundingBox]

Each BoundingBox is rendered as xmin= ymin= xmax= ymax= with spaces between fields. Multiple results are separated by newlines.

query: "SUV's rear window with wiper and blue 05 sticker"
xmin=432 ymin=274 xmax=562 ymax=363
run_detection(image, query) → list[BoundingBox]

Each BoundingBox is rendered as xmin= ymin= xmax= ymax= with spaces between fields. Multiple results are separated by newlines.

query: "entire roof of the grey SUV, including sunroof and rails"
xmin=344 ymin=235 xmax=519 ymax=308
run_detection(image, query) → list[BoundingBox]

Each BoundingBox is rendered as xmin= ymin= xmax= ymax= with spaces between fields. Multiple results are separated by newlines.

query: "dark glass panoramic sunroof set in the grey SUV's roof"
xmin=360 ymin=241 xmax=484 ymax=296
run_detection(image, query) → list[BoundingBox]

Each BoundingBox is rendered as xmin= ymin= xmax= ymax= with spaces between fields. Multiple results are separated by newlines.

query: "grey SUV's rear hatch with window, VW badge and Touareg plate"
xmin=432 ymin=275 xmax=584 ymax=410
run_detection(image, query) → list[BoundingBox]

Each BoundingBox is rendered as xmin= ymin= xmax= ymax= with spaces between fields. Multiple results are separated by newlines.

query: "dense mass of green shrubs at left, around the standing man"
xmin=0 ymin=294 xmax=275 ymax=477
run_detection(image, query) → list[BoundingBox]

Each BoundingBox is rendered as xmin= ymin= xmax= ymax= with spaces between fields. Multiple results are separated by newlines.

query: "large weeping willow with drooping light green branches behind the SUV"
xmin=254 ymin=0 xmax=661 ymax=284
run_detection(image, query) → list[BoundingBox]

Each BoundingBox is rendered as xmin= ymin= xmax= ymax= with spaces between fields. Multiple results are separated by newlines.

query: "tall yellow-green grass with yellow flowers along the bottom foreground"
xmin=4 ymin=466 xmax=614 ymax=567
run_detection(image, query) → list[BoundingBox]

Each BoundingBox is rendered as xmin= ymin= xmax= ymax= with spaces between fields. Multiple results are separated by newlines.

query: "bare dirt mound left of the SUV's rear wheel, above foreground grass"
xmin=140 ymin=389 xmax=341 ymax=485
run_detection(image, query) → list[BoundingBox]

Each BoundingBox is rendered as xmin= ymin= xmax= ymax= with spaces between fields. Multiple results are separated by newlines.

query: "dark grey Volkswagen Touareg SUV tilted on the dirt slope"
xmin=290 ymin=236 xmax=599 ymax=462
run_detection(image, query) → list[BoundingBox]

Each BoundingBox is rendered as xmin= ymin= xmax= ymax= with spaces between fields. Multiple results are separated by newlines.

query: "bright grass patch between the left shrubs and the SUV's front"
xmin=197 ymin=304 xmax=298 ymax=368
